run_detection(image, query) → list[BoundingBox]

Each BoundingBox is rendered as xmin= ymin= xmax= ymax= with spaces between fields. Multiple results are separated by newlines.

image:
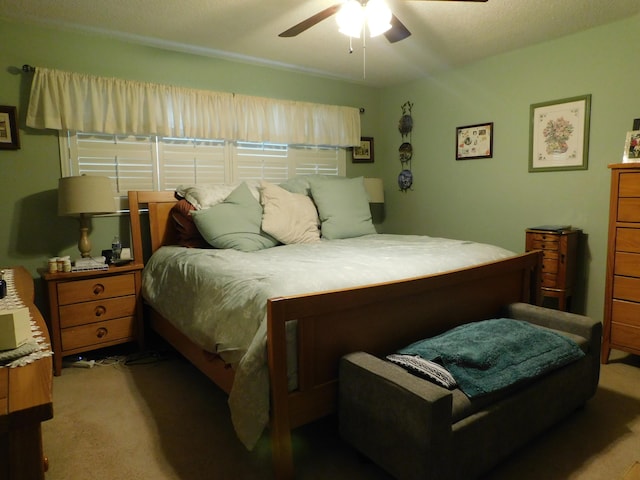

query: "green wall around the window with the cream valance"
xmin=0 ymin=18 xmax=380 ymax=300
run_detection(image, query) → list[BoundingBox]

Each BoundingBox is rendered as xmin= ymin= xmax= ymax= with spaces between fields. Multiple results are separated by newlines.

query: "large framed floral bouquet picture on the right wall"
xmin=529 ymin=95 xmax=591 ymax=172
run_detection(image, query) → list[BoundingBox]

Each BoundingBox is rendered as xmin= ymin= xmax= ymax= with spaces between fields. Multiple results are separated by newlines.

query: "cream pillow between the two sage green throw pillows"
xmin=260 ymin=181 xmax=320 ymax=244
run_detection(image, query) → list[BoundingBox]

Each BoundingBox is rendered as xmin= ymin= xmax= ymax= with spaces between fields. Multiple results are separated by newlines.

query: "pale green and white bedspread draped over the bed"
xmin=142 ymin=234 xmax=514 ymax=449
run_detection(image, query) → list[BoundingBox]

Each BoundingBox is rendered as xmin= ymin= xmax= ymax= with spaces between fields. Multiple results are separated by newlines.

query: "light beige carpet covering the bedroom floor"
xmin=43 ymin=352 xmax=640 ymax=480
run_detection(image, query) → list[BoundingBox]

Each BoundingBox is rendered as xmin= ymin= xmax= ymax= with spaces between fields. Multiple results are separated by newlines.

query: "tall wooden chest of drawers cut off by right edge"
xmin=602 ymin=163 xmax=640 ymax=363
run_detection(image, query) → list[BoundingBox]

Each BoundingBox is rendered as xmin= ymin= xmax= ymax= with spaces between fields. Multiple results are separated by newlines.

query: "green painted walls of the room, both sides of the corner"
xmin=0 ymin=16 xmax=640 ymax=318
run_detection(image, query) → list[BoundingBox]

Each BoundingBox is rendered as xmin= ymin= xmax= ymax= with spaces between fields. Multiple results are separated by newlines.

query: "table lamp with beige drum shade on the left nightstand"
xmin=58 ymin=175 xmax=116 ymax=257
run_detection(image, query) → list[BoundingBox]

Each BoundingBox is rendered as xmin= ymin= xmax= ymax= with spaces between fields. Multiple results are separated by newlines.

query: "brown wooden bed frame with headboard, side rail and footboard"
xmin=129 ymin=191 xmax=541 ymax=479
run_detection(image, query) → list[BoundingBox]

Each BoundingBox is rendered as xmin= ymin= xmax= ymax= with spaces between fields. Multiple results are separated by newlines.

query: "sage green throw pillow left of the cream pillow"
xmin=191 ymin=182 xmax=278 ymax=252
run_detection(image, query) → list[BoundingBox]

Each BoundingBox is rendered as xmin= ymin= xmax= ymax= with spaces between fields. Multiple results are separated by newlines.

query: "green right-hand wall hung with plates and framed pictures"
xmin=377 ymin=16 xmax=640 ymax=318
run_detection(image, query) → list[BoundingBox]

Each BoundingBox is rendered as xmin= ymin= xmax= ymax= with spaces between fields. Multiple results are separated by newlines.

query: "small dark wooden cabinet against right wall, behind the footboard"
xmin=526 ymin=227 xmax=582 ymax=310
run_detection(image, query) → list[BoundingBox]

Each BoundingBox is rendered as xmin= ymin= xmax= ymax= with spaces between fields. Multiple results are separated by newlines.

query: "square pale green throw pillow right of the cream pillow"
xmin=310 ymin=177 xmax=377 ymax=240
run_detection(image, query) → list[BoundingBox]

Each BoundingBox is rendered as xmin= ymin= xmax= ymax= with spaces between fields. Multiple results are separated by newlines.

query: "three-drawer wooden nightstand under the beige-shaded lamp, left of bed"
xmin=38 ymin=264 xmax=144 ymax=375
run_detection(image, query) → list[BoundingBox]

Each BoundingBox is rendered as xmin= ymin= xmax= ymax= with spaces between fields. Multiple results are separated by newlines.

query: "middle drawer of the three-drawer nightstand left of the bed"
xmin=60 ymin=295 xmax=136 ymax=328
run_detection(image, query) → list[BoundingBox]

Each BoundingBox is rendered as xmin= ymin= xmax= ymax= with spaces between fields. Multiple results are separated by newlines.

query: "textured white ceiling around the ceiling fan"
xmin=0 ymin=0 xmax=640 ymax=86
